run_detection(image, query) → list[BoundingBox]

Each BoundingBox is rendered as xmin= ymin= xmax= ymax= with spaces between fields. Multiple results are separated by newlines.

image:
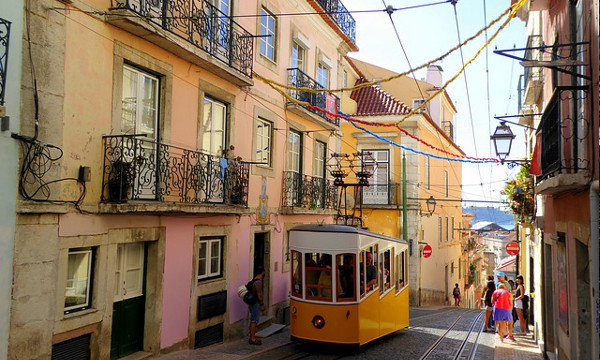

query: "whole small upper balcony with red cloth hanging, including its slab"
xmin=287 ymin=68 xmax=340 ymax=130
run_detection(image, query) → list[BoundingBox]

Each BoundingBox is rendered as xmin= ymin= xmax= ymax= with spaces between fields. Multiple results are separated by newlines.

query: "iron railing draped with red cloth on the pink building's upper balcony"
xmin=288 ymin=68 xmax=340 ymax=126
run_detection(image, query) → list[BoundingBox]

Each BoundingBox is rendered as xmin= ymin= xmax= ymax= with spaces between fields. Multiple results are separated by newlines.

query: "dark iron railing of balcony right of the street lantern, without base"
xmin=536 ymin=88 xmax=591 ymax=183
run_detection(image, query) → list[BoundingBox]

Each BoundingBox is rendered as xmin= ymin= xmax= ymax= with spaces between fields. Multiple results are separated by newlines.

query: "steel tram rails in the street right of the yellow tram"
xmin=419 ymin=310 xmax=484 ymax=360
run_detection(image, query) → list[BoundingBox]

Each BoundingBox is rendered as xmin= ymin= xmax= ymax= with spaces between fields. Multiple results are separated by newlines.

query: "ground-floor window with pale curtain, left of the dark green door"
xmin=65 ymin=248 xmax=93 ymax=313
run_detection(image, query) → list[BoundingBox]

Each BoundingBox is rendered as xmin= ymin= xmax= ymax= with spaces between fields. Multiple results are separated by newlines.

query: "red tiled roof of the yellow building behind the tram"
xmin=350 ymin=78 xmax=411 ymax=115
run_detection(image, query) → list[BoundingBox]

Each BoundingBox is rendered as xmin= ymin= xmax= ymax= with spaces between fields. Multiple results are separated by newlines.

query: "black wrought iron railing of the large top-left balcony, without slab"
xmin=112 ymin=0 xmax=254 ymax=78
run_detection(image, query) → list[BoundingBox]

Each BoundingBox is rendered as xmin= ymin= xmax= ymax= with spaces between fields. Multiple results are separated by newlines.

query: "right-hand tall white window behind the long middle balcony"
xmin=200 ymin=96 xmax=227 ymax=156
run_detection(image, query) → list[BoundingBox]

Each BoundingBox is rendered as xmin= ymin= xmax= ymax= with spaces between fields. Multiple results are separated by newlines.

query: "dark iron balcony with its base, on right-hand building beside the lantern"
xmin=535 ymin=88 xmax=593 ymax=194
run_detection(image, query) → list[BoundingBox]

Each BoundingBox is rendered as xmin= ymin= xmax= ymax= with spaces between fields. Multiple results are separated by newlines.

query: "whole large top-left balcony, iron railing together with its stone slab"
xmin=107 ymin=0 xmax=254 ymax=86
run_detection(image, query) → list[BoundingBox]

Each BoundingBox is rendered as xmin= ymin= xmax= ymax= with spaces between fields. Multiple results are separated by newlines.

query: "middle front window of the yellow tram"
xmin=305 ymin=253 xmax=332 ymax=301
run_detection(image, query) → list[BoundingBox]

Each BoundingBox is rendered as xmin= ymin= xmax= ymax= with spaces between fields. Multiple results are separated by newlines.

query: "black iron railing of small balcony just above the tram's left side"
xmin=282 ymin=171 xmax=338 ymax=210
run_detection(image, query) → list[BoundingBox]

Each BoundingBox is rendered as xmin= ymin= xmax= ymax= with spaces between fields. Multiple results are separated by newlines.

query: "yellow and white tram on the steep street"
xmin=289 ymin=225 xmax=409 ymax=346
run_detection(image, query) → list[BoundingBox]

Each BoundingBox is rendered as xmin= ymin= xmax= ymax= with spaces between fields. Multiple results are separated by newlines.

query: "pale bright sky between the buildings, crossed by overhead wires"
xmin=342 ymin=0 xmax=527 ymax=210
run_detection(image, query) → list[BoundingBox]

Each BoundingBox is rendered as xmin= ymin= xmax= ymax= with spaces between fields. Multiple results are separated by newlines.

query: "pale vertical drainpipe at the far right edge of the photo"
xmin=590 ymin=180 xmax=600 ymax=359
